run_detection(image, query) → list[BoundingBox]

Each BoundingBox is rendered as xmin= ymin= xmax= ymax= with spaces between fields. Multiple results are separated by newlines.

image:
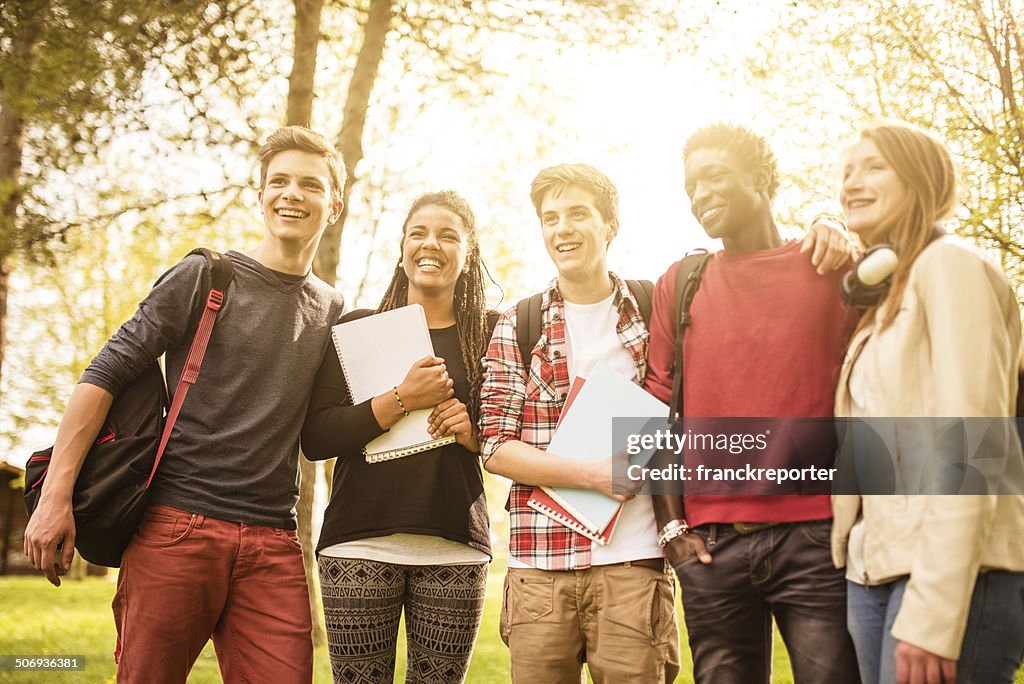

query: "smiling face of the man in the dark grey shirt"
xmin=259 ymin=149 xmax=342 ymax=245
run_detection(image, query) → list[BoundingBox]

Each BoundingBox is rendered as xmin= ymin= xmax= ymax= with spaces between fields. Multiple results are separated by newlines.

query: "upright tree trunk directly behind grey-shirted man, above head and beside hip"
xmin=288 ymin=0 xmax=327 ymax=647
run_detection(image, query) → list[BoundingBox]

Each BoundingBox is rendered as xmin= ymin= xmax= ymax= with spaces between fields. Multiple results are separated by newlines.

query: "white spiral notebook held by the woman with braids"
xmin=331 ymin=304 xmax=455 ymax=463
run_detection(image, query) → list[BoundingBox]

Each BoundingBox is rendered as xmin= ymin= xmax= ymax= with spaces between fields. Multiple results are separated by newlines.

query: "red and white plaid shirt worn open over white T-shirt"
xmin=480 ymin=273 xmax=648 ymax=570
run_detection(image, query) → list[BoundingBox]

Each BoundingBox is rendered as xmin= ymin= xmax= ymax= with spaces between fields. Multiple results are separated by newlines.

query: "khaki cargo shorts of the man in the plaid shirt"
xmin=501 ymin=564 xmax=679 ymax=684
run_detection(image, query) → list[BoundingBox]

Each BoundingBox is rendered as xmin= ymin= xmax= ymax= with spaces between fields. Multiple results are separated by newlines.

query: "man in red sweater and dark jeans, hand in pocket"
xmin=644 ymin=124 xmax=858 ymax=684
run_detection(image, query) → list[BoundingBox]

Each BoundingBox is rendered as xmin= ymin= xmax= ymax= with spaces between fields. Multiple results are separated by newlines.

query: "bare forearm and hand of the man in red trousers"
xmin=25 ymin=383 xmax=114 ymax=587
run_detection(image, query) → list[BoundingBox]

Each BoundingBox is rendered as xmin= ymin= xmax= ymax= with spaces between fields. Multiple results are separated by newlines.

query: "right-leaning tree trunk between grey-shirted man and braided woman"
xmin=313 ymin=0 xmax=394 ymax=285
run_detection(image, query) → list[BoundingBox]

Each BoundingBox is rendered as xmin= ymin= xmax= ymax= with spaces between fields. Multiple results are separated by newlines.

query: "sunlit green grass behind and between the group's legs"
xmin=0 ymin=563 xmax=1024 ymax=684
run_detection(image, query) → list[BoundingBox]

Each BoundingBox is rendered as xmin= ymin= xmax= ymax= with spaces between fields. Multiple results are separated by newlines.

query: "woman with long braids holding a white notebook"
xmin=302 ymin=190 xmax=497 ymax=682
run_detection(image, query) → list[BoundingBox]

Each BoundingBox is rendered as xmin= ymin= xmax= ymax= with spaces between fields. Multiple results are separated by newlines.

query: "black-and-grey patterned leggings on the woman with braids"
xmin=318 ymin=556 xmax=487 ymax=684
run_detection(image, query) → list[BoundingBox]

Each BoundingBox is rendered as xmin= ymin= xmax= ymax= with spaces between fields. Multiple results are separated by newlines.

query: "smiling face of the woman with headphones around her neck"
xmin=840 ymin=138 xmax=908 ymax=245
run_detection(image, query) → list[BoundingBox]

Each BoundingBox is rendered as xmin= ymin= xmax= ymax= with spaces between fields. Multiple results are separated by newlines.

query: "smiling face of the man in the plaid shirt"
xmin=540 ymin=185 xmax=615 ymax=283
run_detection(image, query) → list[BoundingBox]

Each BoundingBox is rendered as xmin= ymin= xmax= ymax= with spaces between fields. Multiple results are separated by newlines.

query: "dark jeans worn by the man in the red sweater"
xmin=676 ymin=520 xmax=859 ymax=684
